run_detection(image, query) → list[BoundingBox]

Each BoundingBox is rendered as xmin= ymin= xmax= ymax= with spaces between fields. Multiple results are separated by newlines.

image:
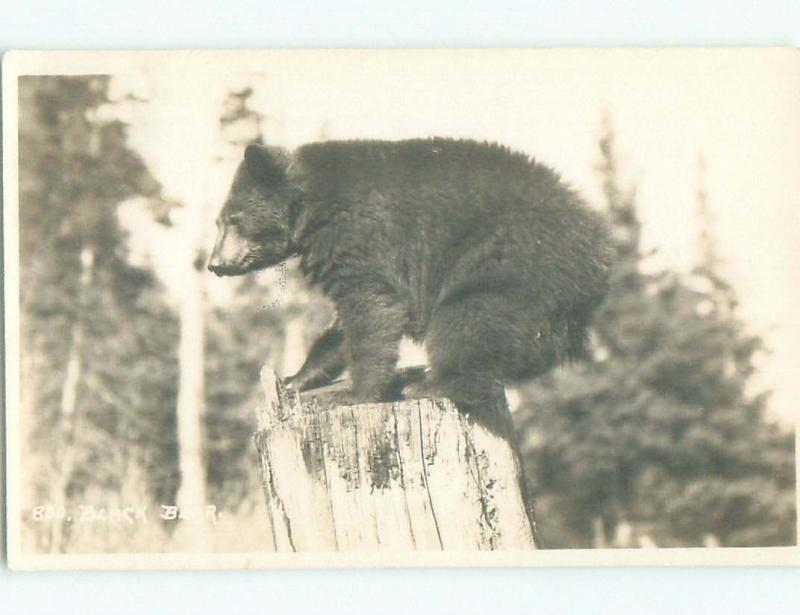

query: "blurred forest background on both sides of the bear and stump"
xmin=19 ymin=76 xmax=796 ymax=553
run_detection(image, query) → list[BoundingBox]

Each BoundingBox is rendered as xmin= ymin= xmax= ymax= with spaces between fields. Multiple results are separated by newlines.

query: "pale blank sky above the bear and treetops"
xmin=94 ymin=50 xmax=800 ymax=418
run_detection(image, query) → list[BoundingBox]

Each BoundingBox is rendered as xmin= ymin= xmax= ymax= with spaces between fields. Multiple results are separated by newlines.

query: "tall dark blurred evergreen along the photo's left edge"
xmin=19 ymin=76 xmax=180 ymax=551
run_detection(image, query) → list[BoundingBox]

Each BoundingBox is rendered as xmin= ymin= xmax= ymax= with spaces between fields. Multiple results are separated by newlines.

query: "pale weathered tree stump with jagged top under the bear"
xmin=254 ymin=367 xmax=535 ymax=552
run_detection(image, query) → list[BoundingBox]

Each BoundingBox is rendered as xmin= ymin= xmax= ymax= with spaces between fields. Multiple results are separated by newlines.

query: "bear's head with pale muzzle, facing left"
xmin=208 ymin=144 xmax=294 ymax=276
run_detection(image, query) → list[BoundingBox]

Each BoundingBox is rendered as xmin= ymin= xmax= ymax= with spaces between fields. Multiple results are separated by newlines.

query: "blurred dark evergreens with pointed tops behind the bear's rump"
xmin=517 ymin=119 xmax=795 ymax=547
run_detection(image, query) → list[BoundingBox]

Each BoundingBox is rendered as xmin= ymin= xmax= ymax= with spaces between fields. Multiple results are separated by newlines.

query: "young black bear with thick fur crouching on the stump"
xmin=208 ymin=138 xmax=612 ymax=428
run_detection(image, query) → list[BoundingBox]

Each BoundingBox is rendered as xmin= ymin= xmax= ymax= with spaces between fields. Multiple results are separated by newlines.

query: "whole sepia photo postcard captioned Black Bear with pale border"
xmin=2 ymin=49 xmax=800 ymax=569
